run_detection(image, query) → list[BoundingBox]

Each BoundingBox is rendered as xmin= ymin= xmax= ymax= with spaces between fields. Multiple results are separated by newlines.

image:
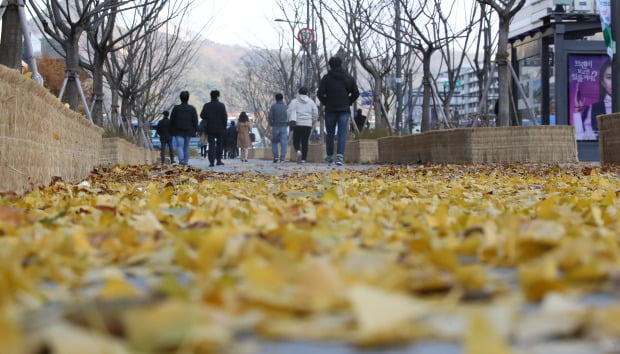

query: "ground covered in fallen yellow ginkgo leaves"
xmin=0 ymin=165 xmax=620 ymax=354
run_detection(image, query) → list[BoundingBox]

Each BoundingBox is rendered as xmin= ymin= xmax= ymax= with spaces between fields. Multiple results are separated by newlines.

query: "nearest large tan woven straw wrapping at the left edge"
xmin=0 ymin=65 xmax=103 ymax=193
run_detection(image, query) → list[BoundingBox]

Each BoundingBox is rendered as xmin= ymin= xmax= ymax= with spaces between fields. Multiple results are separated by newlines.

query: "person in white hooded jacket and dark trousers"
xmin=286 ymin=87 xmax=319 ymax=163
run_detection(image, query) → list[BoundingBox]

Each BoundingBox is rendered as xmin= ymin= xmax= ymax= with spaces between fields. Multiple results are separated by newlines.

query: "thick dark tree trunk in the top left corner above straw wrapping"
xmin=0 ymin=5 xmax=23 ymax=71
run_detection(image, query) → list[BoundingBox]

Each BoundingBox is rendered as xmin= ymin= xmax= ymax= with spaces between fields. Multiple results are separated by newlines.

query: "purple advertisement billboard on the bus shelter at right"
xmin=568 ymin=55 xmax=611 ymax=140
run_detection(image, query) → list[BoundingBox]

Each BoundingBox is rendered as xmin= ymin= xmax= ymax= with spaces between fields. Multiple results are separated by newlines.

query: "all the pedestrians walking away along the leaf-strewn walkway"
xmin=157 ymin=57 xmax=363 ymax=167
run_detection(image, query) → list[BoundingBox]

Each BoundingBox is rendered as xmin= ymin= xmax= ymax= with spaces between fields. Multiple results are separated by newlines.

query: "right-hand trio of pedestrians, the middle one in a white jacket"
xmin=268 ymin=57 xmax=359 ymax=165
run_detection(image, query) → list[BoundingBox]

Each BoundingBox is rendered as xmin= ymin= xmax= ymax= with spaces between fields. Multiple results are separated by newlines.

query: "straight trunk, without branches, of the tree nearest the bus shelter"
xmin=495 ymin=16 xmax=511 ymax=127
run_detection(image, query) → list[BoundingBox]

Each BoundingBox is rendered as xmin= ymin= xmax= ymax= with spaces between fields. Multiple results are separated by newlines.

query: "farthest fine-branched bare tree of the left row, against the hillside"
xmin=106 ymin=1 xmax=199 ymax=146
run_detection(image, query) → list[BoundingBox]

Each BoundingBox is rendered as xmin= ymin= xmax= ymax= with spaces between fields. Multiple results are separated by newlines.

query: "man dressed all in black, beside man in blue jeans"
xmin=200 ymin=90 xmax=228 ymax=167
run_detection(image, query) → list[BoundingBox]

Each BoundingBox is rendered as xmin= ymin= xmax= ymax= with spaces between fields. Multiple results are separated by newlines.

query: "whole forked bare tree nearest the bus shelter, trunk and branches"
xmin=477 ymin=0 xmax=526 ymax=126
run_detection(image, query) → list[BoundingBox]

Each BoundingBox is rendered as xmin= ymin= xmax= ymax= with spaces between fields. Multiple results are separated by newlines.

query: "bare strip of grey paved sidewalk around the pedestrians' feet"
xmin=189 ymin=158 xmax=380 ymax=175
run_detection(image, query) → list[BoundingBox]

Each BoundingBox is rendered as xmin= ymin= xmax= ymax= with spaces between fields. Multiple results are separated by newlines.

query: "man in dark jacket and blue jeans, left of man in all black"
xmin=170 ymin=91 xmax=198 ymax=165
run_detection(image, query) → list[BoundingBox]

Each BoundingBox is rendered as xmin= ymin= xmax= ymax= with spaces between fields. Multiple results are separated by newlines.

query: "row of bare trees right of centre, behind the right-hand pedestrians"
xmin=235 ymin=0 xmax=525 ymax=136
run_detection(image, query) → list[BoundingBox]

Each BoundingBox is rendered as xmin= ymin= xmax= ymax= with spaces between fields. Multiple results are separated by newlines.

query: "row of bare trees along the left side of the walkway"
xmin=3 ymin=0 xmax=199 ymax=146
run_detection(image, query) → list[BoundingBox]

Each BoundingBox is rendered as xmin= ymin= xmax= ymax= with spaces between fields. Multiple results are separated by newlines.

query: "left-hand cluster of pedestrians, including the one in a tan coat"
xmin=157 ymin=90 xmax=251 ymax=167
